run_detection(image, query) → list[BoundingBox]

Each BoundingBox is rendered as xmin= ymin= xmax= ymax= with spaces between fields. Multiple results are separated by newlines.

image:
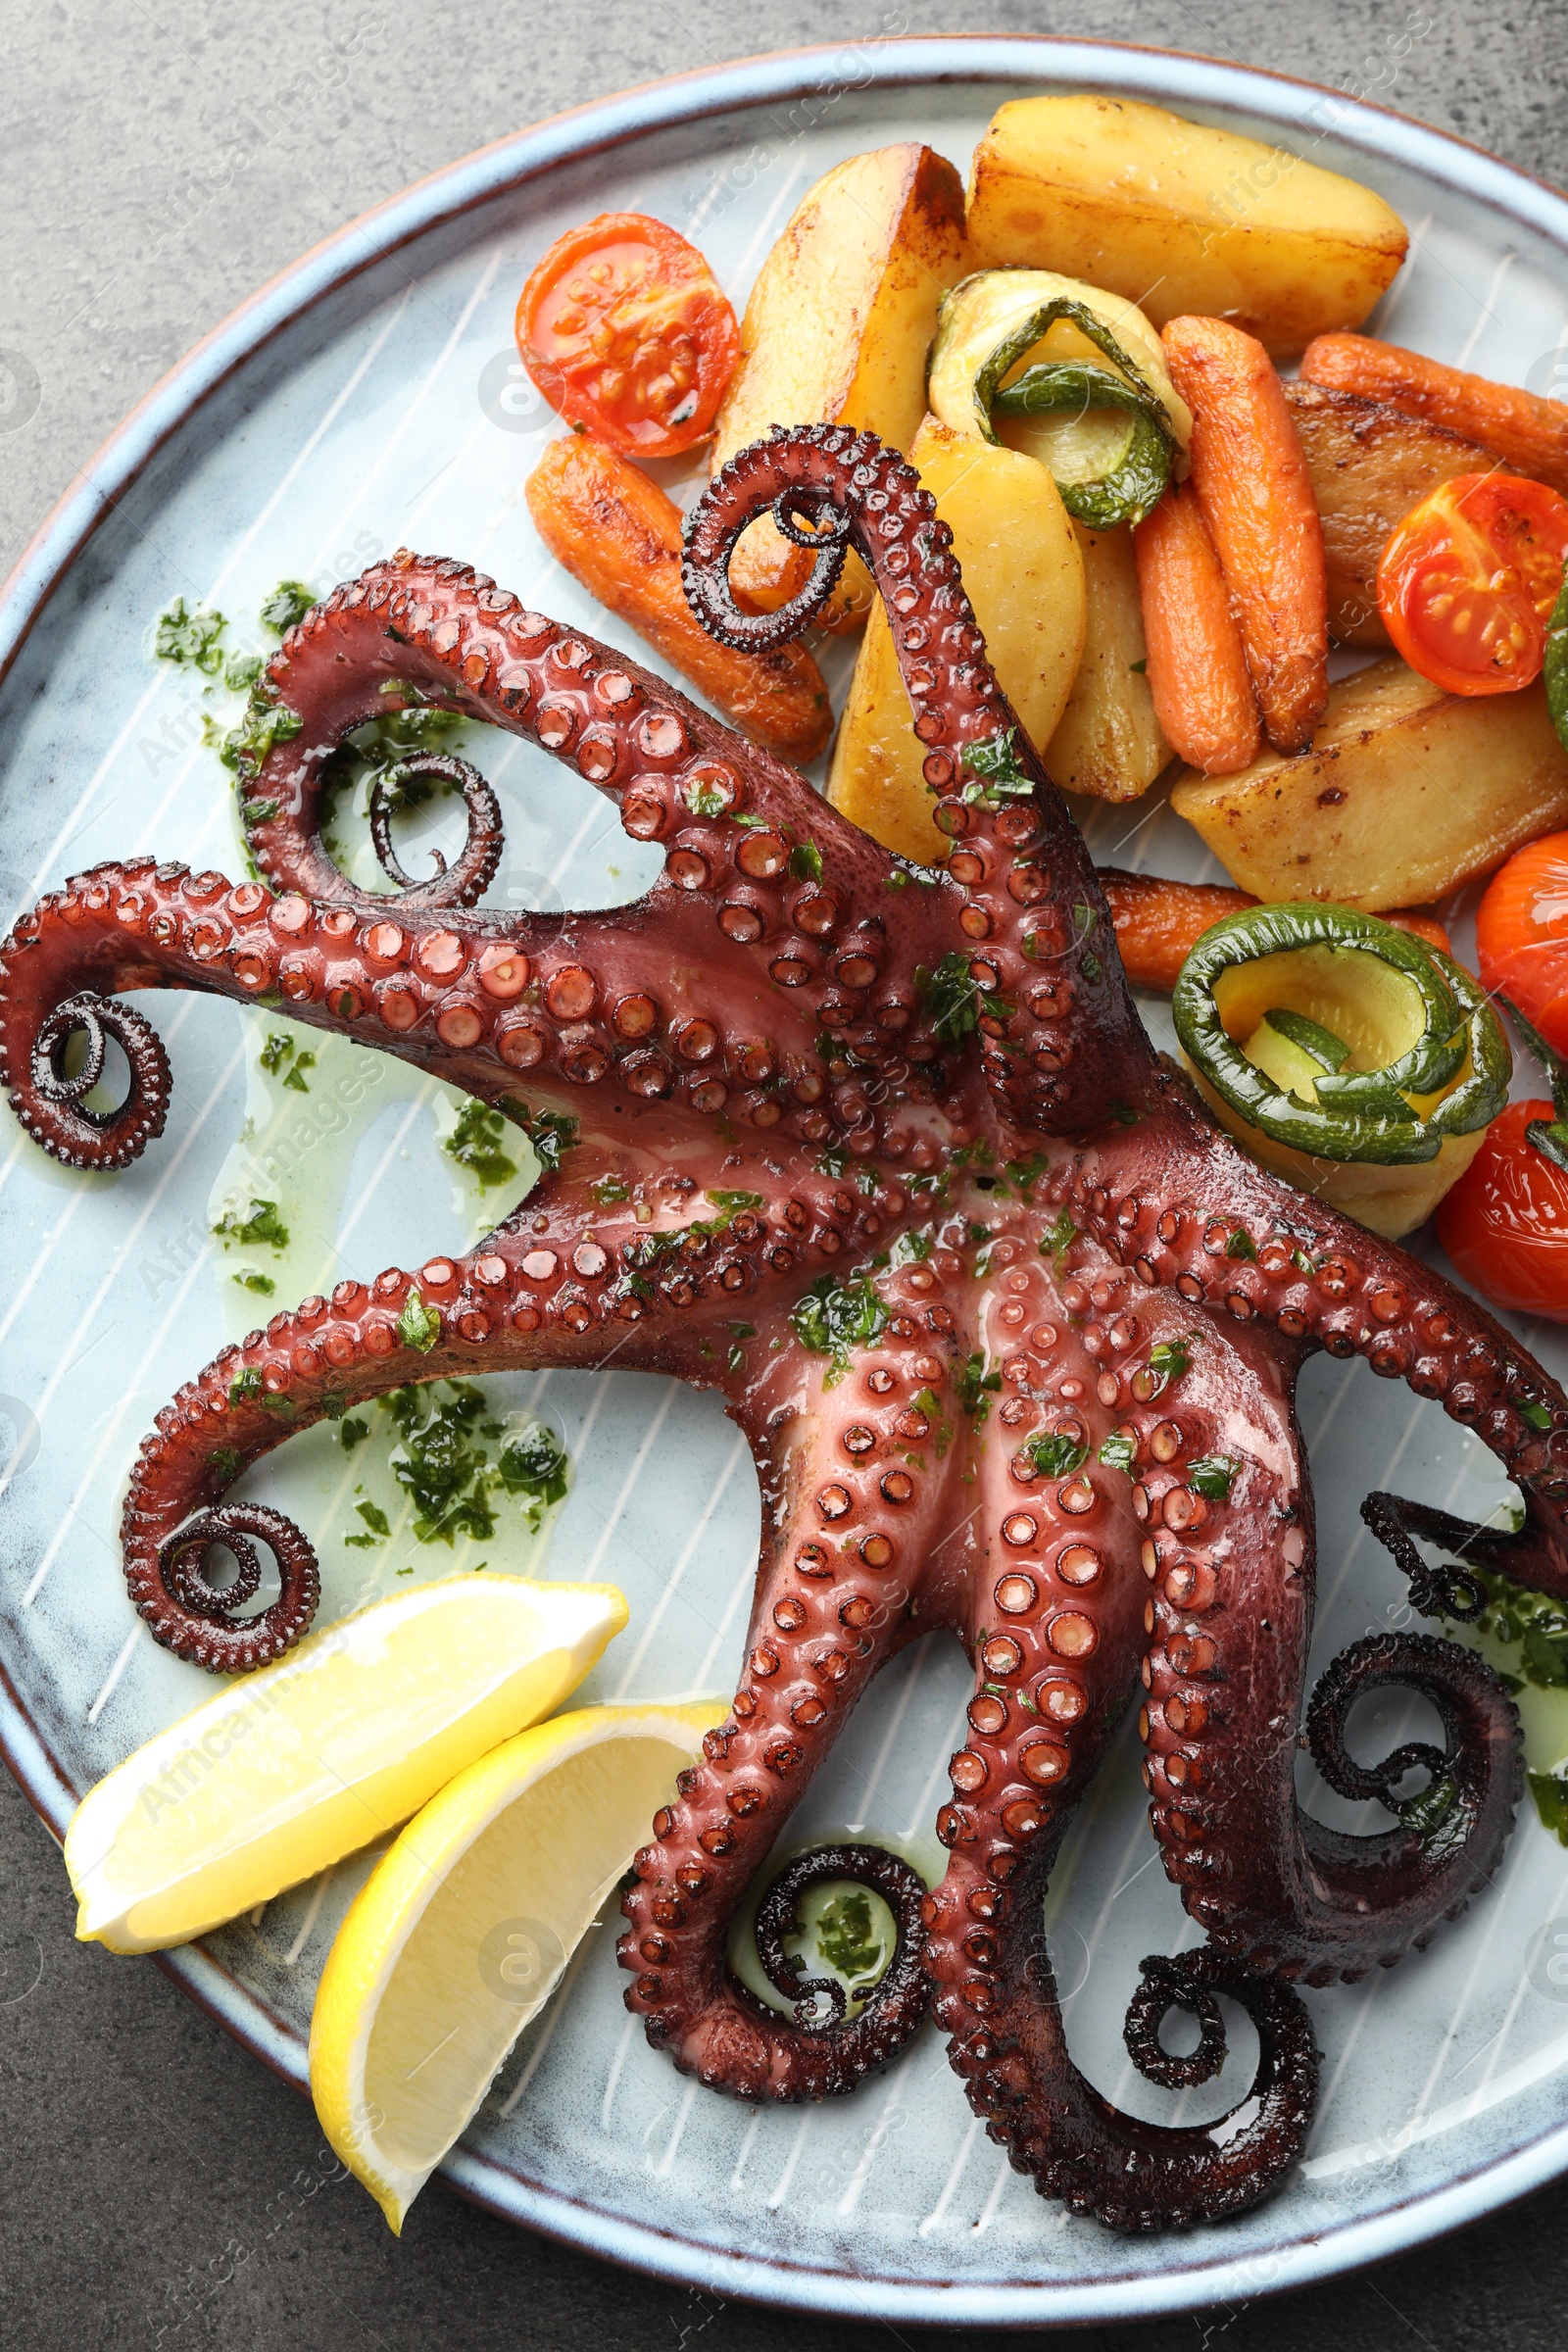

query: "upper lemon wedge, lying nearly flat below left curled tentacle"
xmin=66 ymin=1576 xmax=625 ymax=1952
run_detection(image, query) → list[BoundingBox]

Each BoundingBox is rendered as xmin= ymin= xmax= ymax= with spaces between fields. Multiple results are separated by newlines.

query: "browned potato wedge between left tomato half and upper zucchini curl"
xmin=712 ymin=141 xmax=968 ymax=621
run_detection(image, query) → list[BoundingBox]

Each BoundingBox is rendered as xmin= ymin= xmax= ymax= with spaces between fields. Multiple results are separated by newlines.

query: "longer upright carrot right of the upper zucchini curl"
xmin=1161 ymin=318 xmax=1328 ymax=753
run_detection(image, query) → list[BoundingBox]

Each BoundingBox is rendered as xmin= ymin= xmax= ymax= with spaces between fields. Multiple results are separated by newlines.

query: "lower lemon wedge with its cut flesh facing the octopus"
xmin=311 ymin=1700 xmax=726 ymax=2232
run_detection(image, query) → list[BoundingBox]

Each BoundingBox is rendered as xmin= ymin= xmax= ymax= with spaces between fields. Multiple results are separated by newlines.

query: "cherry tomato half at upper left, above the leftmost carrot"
xmin=517 ymin=212 xmax=741 ymax=457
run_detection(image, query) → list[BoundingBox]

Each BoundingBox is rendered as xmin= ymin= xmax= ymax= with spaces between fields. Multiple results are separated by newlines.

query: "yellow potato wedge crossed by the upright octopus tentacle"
xmin=827 ymin=416 xmax=1084 ymax=865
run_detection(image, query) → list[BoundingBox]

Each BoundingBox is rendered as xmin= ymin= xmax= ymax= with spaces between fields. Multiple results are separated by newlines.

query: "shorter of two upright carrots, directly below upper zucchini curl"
xmin=1133 ymin=484 xmax=1262 ymax=776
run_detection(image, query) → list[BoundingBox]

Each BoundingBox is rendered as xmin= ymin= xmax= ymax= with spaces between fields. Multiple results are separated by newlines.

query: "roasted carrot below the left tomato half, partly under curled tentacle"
xmin=526 ymin=433 xmax=832 ymax=764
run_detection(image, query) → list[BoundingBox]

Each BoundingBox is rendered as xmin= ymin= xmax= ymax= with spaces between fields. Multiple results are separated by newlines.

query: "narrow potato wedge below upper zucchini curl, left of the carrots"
xmin=1034 ymin=519 xmax=1171 ymax=800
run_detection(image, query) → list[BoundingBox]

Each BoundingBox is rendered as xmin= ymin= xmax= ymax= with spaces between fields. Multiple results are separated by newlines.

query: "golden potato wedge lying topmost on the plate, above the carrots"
xmin=968 ymin=96 xmax=1408 ymax=358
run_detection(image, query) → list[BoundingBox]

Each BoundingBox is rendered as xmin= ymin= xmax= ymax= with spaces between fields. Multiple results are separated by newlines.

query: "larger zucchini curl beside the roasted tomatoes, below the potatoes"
xmin=1171 ymin=904 xmax=1511 ymax=1237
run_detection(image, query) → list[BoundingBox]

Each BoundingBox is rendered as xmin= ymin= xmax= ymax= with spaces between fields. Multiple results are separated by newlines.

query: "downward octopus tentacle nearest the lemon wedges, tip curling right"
xmin=618 ymin=1307 xmax=971 ymax=2103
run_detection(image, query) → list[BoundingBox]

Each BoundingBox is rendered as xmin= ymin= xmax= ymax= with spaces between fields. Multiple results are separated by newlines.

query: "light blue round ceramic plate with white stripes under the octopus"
xmin=0 ymin=40 xmax=1568 ymax=2324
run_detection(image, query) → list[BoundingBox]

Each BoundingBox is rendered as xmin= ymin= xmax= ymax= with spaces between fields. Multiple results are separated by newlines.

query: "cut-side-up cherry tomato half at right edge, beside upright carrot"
xmin=1378 ymin=472 xmax=1568 ymax=694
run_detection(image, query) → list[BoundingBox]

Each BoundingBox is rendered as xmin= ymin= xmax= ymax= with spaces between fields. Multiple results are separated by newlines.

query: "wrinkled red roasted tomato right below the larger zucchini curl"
xmin=1437 ymin=1103 xmax=1568 ymax=1322
